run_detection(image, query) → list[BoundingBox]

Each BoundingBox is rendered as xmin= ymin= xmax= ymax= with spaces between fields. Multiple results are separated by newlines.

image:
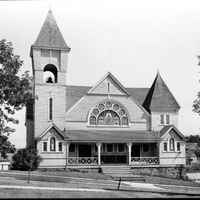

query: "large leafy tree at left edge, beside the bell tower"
xmin=0 ymin=39 xmax=34 ymax=158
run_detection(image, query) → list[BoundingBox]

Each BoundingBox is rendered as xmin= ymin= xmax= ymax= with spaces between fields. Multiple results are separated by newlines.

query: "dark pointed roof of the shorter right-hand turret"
xmin=143 ymin=71 xmax=180 ymax=112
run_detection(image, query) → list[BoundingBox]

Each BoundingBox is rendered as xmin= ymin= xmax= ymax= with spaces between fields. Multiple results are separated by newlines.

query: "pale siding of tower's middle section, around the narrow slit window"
xmin=35 ymin=85 xmax=66 ymax=137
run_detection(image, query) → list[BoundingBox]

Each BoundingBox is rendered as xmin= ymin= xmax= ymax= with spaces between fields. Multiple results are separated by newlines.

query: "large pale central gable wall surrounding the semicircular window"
xmin=66 ymin=72 xmax=150 ymax=122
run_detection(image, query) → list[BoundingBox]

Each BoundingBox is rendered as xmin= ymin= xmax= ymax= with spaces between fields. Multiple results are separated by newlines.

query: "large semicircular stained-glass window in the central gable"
xmin=89 ymin=101 xmax=128 ymax=126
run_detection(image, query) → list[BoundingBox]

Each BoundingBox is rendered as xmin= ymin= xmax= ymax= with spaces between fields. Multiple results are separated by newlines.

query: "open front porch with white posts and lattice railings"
xmin=66 ymin=142 xmax=159 ymax=167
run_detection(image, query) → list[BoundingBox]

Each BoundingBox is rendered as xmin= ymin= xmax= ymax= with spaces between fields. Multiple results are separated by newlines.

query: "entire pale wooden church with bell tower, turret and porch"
xmin=26 ymin=10 xmax=186 ymax=169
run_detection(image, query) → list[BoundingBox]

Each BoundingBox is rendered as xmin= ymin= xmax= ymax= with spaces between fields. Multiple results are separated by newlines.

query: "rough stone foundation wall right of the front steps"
xmin=132 ymin=166 xmax=188 ymax=180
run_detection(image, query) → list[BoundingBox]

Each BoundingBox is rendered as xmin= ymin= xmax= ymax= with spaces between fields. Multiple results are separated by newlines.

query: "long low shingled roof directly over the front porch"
xmin=64 ymin=130 xmax=160 ymax=143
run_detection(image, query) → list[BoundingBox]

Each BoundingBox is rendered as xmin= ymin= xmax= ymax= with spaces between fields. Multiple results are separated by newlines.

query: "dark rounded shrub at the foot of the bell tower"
xmin=11 ymin=147 xmax=42 ymax=170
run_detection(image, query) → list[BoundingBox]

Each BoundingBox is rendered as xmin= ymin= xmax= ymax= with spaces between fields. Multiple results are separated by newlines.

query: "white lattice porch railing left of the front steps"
xmin=68 ymin=157 xmax=98 ymax=165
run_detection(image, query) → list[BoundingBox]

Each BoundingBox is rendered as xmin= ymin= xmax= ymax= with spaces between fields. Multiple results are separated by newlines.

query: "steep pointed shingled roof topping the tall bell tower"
xmin=32 ymin=9 xmax=70 ymax=51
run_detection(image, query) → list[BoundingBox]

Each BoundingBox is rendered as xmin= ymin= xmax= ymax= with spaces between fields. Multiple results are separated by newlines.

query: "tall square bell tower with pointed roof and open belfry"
xmin=30 ymin=10 xmax=70 ymax=140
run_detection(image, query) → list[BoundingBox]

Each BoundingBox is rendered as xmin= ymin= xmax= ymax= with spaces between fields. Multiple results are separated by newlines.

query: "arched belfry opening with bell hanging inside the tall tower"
xmin=43 ymin=64 xmax=58 ymax=83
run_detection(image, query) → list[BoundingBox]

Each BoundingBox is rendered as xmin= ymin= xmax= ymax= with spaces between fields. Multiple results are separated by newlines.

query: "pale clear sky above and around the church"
xmin=0 ymin=0 xmax=200 ymax=148
